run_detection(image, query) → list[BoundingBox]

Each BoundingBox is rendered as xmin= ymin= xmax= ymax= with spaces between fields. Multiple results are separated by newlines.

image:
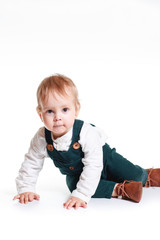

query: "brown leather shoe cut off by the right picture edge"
xmin=145 ymin=168 xmax=160 ymax=187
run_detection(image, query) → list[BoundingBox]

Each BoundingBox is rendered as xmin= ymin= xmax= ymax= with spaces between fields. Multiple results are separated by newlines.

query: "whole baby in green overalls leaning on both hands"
xmin=14 ymin=75 xmax=160 ymax=209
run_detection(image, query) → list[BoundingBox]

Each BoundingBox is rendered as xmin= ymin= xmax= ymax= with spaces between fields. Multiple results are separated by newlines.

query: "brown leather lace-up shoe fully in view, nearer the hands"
xmin=115 ymin=181 xmax=142 ymax=203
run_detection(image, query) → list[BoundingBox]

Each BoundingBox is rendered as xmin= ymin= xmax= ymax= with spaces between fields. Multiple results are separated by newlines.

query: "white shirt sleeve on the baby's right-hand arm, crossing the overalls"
xmin=71 ymin=123 xmax=103 ymax=202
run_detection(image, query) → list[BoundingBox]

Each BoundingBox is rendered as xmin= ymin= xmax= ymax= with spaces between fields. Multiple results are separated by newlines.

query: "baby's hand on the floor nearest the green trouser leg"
xmin=63 ymin=197 xmax=87 ymax=210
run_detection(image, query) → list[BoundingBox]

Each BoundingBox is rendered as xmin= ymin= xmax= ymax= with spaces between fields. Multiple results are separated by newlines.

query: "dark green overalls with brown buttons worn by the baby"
xmin=45 ymin=120 xmax=148 ymax=198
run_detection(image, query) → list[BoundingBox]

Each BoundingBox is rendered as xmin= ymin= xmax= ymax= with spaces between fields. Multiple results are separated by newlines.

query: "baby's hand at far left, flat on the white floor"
xmin=13 ymin=192 xmax=40 ymax=204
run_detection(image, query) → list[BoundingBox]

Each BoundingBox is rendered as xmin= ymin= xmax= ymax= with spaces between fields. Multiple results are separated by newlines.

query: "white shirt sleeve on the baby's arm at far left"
xmin=16 ymin=128 xmax=46 ymax=194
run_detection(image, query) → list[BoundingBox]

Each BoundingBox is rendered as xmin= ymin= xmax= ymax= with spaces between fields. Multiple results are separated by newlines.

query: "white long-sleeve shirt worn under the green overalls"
xmin=16 ymin=123 xmax=106 ymax=202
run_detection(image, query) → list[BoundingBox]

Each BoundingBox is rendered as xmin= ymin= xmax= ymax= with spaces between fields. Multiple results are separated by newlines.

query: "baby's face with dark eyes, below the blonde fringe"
xmin=39 ymin=92 xmax=79 ymax=139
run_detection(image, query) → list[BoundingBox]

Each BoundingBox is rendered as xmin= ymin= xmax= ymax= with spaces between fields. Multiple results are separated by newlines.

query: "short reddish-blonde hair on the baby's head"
xmin=37 ymin=74 xmax=80 ymax=112
